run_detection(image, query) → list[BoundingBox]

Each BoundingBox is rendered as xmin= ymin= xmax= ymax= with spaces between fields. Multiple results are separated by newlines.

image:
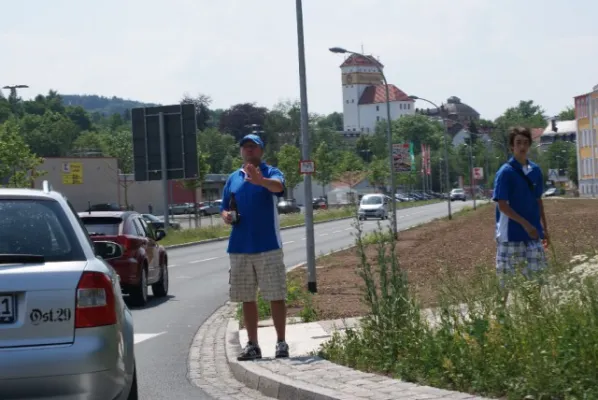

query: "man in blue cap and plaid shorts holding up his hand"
xmin=220 ymin=135 xmax=289 ymax=361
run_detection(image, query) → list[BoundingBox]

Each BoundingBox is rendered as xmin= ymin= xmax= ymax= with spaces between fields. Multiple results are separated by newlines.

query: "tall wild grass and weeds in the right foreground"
xmin=319 ymin=211 xmax=598 ymax=400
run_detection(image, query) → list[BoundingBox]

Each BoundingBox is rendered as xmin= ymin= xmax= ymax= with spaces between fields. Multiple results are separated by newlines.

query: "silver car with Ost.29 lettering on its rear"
xmin=0 ymin=182 xmax=137 ymax=400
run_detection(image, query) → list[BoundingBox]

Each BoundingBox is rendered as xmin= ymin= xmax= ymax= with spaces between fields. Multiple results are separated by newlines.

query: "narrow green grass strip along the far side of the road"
xmin=160 ymin=200 xmax=442 ymax=246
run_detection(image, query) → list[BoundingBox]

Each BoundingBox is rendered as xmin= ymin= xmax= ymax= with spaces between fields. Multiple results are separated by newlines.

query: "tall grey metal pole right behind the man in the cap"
xmin=295 ymin=0 xmax=318 ymax=293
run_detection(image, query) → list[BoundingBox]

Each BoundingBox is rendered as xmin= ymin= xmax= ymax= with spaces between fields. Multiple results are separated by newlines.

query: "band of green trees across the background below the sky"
xmin=0 ymin=91 xmax=577 ymax=194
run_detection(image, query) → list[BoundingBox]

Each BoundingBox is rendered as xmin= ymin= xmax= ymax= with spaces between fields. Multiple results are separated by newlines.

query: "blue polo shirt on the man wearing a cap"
xmin=220 ymin=162 xmax=285 ymax=253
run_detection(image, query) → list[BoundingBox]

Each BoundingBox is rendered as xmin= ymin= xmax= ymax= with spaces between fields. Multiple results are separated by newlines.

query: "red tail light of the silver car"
xmin=75 ymin=271 xmax=116 ymax=328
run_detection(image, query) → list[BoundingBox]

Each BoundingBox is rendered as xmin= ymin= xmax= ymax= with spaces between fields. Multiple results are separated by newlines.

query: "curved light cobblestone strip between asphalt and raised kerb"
xmin=188 ymin=304 xmax=271 ymax=400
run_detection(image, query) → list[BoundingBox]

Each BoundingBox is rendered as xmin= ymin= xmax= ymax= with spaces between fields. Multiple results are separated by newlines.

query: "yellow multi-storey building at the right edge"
xmin=574 ymin=85 xmax=598 ymax=197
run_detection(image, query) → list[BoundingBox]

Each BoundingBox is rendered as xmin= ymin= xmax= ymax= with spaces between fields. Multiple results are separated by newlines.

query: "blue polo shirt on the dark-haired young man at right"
xmin=492 ymin=157 xmax=544 ymax=242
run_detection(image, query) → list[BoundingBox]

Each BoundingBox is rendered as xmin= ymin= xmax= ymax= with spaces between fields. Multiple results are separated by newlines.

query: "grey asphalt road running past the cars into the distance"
xmin=132 ymin=201 xmax=472 ymax=400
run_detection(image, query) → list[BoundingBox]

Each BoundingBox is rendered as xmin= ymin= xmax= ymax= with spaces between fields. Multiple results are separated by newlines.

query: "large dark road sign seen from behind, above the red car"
xmin=131 ymin=104 xmax=198 ymax=181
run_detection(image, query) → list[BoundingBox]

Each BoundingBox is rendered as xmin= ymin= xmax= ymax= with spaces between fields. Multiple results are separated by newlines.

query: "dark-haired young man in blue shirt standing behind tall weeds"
xmin=492 ymin=127 xmax=548 ymax=292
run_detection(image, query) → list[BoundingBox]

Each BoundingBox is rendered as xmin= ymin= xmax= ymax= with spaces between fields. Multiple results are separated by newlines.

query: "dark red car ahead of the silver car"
xmin=79 ymin=211 xmax=168 ymax=306
